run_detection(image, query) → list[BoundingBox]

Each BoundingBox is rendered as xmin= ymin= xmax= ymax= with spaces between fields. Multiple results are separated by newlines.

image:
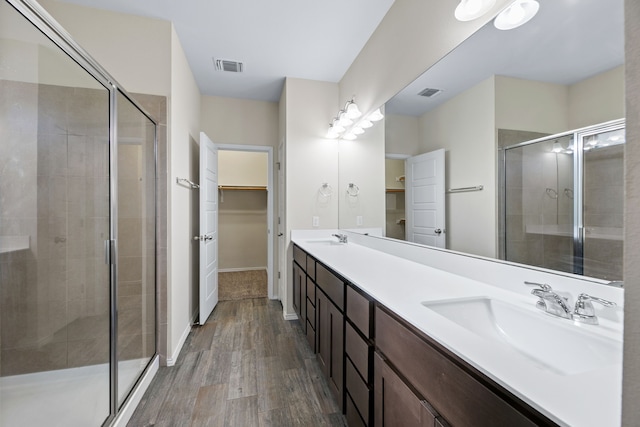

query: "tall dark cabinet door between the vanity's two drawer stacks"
xmin=316 ymin=290 xmax=344 ymax=410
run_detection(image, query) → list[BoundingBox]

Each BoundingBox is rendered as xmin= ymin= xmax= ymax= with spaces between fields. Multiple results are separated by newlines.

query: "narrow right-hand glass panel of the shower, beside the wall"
xmin=116 ymin=92 xmax=156 ymax=406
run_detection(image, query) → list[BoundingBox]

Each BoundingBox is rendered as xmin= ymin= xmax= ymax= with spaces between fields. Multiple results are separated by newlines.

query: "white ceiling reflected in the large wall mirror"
xmin=386 ymin=0 xmax=624 ymax=116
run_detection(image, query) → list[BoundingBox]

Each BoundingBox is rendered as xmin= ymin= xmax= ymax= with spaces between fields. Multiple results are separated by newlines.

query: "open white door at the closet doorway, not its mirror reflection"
xmin=198 ymin=132 xmax=218 ymax=325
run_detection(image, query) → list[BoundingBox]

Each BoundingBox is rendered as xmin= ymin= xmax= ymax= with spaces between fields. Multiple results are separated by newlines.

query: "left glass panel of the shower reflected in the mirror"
xmin=504 ymin=135 xmax=574 ymax=273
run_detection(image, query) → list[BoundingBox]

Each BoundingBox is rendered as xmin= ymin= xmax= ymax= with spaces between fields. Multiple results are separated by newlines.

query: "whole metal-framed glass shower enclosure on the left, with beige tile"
xmin=0 ymin=0 xmax=156 ymax=427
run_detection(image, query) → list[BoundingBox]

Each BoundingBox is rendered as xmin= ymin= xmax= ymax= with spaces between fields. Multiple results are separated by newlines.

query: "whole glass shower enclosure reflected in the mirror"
xmin=499 ymin=120 xmax=625 ymax=281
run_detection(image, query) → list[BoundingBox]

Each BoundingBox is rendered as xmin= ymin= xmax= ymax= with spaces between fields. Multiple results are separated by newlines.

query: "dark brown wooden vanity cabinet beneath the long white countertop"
xmin=293 ymin=245 xmax=556 ymax=427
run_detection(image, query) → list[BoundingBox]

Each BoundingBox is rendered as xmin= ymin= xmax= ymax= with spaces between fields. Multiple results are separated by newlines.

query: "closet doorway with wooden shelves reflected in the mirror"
xmin=385 ymin=155 xmax=408 ymax=240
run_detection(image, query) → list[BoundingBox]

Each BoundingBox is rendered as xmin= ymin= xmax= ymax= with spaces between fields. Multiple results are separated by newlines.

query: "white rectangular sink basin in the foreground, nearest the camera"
xmin=422 ymin=297 xmax=622 ymax=375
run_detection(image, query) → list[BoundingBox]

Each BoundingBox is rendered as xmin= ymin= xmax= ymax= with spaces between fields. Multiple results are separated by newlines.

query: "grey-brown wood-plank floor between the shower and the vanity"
xmin=128 ymin=298 xmax=346 ymax=427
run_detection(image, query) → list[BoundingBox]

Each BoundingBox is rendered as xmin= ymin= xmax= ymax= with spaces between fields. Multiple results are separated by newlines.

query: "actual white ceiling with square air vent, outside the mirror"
xmin=53 ymin=0 xmax=393 ymax=101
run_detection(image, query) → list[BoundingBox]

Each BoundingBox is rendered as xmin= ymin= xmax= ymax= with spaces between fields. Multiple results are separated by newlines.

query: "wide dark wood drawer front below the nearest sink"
xmin=375 ymin=308 xmax=554 ymax=427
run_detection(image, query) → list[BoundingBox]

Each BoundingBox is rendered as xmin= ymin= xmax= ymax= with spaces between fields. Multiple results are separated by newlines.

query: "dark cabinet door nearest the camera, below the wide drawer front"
xmin=374 ymin=353 xmax=435 ymax=427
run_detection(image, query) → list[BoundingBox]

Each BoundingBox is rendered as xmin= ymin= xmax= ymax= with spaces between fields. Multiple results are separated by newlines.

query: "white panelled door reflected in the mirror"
xmin=405 ymin=149 xmax=446 ymax=248
